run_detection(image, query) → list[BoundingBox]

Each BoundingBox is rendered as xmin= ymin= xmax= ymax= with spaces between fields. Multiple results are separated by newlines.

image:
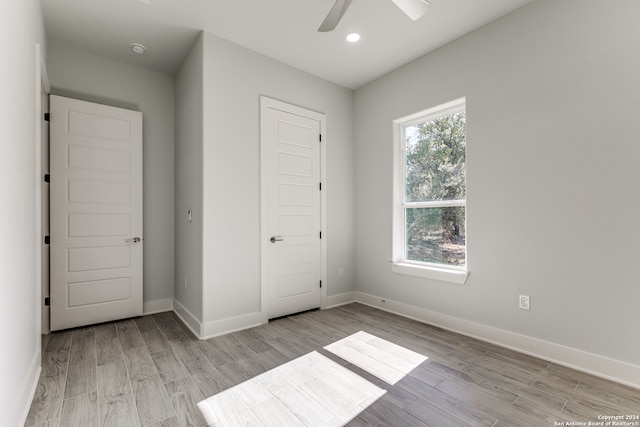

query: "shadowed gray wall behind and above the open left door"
xmin=47 ymin=44 xmax=174 ymax=308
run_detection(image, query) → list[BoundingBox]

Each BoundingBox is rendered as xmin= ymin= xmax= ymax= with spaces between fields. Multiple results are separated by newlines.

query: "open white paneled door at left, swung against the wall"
xmin=50 ymin=96 xmax=143 ymax=330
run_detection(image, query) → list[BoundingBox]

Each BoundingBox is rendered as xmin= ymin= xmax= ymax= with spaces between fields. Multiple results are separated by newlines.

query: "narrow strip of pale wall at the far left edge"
xmin=0 ymin=0 xmax=46 ymax=426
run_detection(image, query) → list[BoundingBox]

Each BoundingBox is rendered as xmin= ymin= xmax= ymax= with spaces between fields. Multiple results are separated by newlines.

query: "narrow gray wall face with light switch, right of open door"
xmin=175 ymin=37 xmax=203 ymax=321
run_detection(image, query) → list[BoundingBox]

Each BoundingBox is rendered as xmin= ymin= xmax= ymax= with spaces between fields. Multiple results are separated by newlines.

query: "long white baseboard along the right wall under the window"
xmin=354 ymin=292 xmax=640 ymax=389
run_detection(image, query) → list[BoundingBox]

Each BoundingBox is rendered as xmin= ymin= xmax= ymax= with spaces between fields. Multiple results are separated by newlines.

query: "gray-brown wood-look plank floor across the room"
xmin=26 ymin=304 xmax=640 ymax=427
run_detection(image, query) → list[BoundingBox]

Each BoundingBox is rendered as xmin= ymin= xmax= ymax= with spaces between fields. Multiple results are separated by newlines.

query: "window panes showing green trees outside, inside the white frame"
xmin=402 ymin=109 xmax=466 ymax=267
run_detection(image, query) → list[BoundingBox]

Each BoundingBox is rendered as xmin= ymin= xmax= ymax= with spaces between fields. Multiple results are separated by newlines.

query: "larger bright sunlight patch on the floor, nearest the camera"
xmin=198 ymin=351 xmax=385 ymax=427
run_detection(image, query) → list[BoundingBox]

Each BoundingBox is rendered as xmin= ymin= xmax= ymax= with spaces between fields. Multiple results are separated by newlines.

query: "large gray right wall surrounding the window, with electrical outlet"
xmin=355 ymin=0 xmax=640 ymax=364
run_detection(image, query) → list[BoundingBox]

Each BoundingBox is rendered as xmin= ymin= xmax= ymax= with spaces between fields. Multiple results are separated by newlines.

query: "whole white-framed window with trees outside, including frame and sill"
xmin=393 ymin=99 xmax=467 ymax=283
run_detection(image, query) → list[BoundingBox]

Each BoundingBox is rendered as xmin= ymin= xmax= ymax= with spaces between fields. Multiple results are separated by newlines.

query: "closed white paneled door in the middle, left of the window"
xmin=261 ymin=98 xmax=323 ymax=318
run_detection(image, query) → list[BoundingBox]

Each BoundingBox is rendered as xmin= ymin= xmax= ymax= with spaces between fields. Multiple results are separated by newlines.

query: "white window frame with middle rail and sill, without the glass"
xmin=391 ymin=98 xmax=469 ymax=284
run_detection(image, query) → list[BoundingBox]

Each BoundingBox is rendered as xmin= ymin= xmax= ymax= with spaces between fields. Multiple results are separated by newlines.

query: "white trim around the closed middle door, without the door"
xmin=260 ymin=96 xmax=328 ymax=323
